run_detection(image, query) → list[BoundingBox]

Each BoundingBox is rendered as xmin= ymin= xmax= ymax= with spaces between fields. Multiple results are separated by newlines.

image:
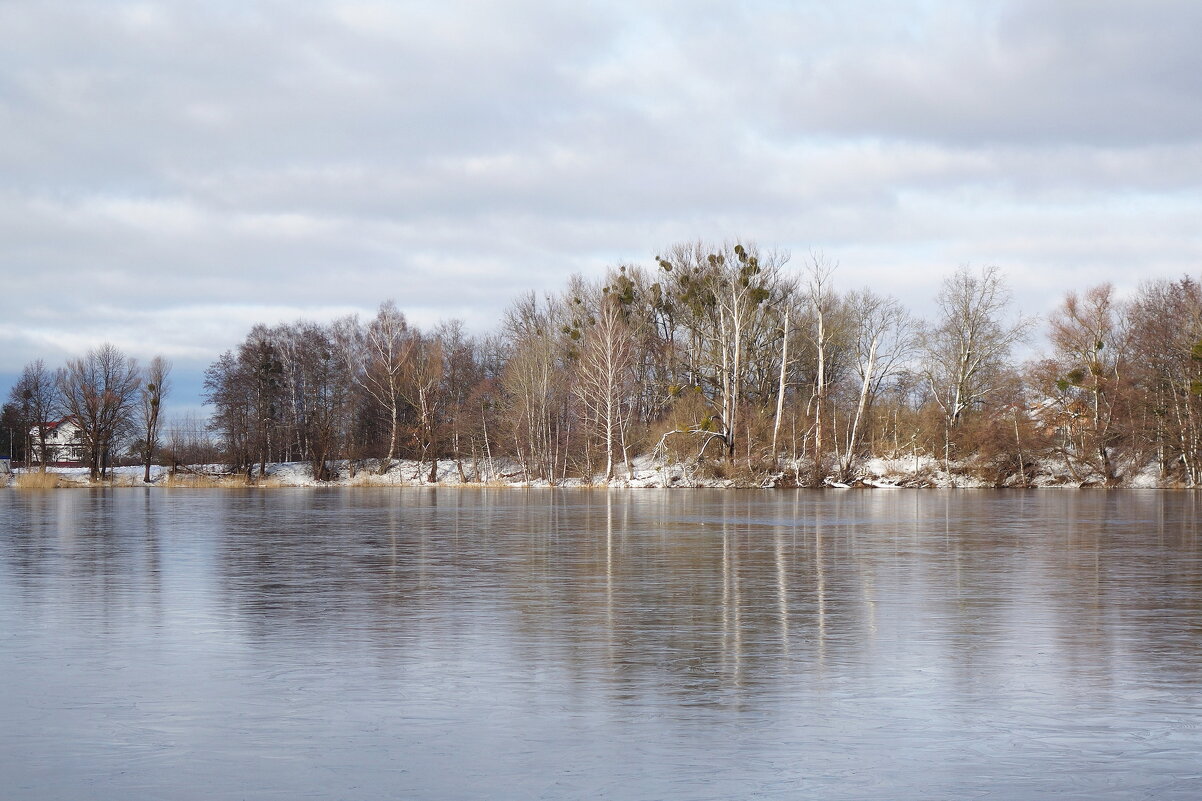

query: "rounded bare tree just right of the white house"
xmin=58 ymin=343 xmax=141 ymax=481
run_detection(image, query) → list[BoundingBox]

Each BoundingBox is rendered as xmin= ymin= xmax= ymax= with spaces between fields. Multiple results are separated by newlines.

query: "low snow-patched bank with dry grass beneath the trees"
xmin=0 ymin=456 xmax=1183 ymax=490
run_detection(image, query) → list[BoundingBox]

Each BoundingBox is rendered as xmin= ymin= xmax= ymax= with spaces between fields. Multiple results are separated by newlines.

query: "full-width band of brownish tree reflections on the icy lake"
xmin=2 ymin=488 xmax=1202 ymax=704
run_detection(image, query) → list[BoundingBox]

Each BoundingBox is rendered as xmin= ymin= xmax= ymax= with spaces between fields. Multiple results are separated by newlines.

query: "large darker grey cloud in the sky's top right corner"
xmin=785 ymin=1 xmax=1202 ymax=146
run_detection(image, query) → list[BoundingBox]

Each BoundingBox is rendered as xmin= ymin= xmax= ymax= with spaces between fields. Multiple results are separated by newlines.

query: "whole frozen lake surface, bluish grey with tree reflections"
xmin=0 ymin=490 xmax=1202 ymax=801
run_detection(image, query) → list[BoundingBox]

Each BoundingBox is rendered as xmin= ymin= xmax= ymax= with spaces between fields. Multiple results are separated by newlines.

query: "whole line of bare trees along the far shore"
xmin=2 ymin=243 xmax=1202 ymax=487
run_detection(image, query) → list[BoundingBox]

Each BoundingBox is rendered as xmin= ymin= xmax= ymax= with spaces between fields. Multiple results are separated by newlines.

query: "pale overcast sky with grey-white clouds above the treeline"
xmin=0 ymin=0 xmax=1202 ymax=408
